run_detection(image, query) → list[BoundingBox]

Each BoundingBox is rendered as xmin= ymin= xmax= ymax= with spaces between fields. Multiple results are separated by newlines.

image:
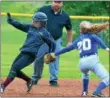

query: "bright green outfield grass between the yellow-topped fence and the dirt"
xmin=1 ymin=18 xmax=109 ymax=79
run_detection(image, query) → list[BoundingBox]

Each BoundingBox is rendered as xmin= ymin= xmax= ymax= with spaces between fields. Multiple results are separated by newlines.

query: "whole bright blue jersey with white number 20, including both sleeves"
xmin=55 ymin=33 xmax=107 ymax=57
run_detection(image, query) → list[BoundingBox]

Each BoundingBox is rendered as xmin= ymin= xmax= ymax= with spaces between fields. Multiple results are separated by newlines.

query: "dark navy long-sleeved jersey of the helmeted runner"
xmin=8 ymin=19 xmax=55 ymax=55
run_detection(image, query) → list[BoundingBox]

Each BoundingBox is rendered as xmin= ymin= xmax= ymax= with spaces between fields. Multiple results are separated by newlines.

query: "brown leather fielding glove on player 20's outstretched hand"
xmin=44 ymin=53 xmax=56 ymax=64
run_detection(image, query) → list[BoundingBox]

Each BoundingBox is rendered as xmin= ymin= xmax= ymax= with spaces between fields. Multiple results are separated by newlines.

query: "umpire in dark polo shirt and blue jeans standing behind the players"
xmin=33 ymin=0 xmax=72 ymax=86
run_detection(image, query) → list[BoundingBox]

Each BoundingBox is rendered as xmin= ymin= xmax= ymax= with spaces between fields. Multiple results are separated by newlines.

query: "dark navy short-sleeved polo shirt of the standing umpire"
xmin=39 ymin=6 xmax=72 ymax=40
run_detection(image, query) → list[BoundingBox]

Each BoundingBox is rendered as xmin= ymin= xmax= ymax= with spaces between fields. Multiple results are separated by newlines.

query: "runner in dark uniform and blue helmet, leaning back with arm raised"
xmin=0 ymin=12 xmax=55 ymax=92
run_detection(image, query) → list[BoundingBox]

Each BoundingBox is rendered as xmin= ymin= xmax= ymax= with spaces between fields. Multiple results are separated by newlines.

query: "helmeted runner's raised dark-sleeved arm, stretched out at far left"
xmin=7 ymin=13 xmax=30 ymax=32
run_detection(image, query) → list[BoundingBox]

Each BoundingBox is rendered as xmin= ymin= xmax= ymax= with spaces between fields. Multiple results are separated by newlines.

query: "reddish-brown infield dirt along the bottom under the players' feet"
xmin=1 ymin=79 xmax=110 ymax=97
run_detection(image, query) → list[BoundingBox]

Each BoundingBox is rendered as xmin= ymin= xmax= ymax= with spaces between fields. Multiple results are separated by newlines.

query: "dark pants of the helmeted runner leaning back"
xmin=8 ymin=52 xmax=36 ymax=78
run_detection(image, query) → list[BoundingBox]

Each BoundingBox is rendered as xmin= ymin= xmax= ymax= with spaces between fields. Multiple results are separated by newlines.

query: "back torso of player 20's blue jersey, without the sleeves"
xmin=77 ymin=33 xmax=97 ymax=57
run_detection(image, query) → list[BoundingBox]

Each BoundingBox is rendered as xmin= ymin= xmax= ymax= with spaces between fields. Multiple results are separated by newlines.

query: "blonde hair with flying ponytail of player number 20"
xmin=80 ymin=21 xmax=109 ymax=34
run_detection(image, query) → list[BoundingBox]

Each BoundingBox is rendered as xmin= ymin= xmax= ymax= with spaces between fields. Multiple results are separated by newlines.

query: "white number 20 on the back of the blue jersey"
xmin=78 ymin=39 xmax=91 ymax=52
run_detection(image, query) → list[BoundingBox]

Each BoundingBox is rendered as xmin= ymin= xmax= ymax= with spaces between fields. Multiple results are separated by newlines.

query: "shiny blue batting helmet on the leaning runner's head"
xmin=32 ymin=12 xmax=47 ymax=21
